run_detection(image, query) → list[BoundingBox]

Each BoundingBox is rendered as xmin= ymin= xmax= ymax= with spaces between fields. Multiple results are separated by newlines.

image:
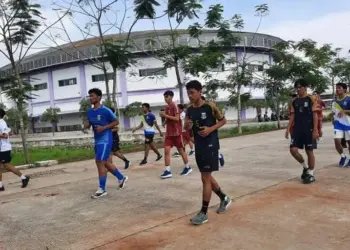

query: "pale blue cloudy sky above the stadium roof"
xmin=0 ymin=0 xmax=350 ymax=65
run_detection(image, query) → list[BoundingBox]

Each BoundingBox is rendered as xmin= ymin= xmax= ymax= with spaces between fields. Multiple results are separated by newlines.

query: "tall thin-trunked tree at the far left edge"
xmin=0 ymin=0 xmax=65 ymax=163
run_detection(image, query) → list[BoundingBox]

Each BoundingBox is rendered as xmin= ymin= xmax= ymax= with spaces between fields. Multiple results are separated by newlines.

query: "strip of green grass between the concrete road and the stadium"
xmin=12 ymin=124 xmax=276 ymax=166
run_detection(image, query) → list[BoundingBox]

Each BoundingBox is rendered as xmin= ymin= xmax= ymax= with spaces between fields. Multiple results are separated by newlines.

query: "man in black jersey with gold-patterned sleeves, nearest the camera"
xmin=186 ymin=80 xmax=231 ymax=225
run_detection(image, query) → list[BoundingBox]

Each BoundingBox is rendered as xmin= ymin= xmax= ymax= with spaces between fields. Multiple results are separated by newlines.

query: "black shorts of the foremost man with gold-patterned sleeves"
xmin=195 ymin=147 xmax=219 ymax=173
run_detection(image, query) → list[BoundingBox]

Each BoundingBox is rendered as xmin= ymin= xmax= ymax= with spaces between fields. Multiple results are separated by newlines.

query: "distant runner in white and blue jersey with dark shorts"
xmin=132 ymin=103 xmax=163 ymax=165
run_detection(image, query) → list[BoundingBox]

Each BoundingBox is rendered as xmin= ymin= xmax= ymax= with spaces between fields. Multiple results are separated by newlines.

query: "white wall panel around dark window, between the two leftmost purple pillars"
xmin=52 ymin=66 xmax=81 ymax=100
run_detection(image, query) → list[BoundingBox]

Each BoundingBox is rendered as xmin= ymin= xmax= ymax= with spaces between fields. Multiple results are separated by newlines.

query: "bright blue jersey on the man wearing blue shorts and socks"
xmin=87 ymin=105 xmax=117 ymax=145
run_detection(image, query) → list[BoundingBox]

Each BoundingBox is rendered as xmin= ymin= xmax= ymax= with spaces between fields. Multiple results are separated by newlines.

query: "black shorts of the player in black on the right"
xmin=290 ymin=130 xmax=317 ymax=151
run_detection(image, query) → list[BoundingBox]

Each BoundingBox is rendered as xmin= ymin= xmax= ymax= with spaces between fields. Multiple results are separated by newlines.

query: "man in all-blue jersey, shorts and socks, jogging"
xmin=85 ymin=88 xmax=128 ymax=199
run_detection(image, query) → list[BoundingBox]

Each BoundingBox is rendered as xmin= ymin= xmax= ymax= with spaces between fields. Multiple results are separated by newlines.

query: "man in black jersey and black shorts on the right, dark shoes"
xmin=286 ymin=79 xmax=318 ymax=184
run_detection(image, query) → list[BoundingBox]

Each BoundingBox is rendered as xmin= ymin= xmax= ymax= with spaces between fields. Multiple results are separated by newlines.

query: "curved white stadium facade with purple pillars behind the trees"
xmin=0 ymin=30 xmax=282 ymax=132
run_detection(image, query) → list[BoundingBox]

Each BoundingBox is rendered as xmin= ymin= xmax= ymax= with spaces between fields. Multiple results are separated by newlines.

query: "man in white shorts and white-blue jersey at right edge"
xmin=332 ymin=83 xmax=350 ymax=167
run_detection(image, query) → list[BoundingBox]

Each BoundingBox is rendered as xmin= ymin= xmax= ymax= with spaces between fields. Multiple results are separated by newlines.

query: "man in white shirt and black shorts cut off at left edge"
xmin=0 ymin=109 xmax=30 ymax=191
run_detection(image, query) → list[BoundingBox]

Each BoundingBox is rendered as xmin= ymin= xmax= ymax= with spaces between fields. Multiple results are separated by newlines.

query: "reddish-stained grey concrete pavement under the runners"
xmin=0 ymin=126 xmax=350 ymax=250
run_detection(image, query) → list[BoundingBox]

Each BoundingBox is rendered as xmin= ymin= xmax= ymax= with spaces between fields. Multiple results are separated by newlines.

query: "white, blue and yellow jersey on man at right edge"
xmin=332 ymin=96 xmax=350 ymax=131
